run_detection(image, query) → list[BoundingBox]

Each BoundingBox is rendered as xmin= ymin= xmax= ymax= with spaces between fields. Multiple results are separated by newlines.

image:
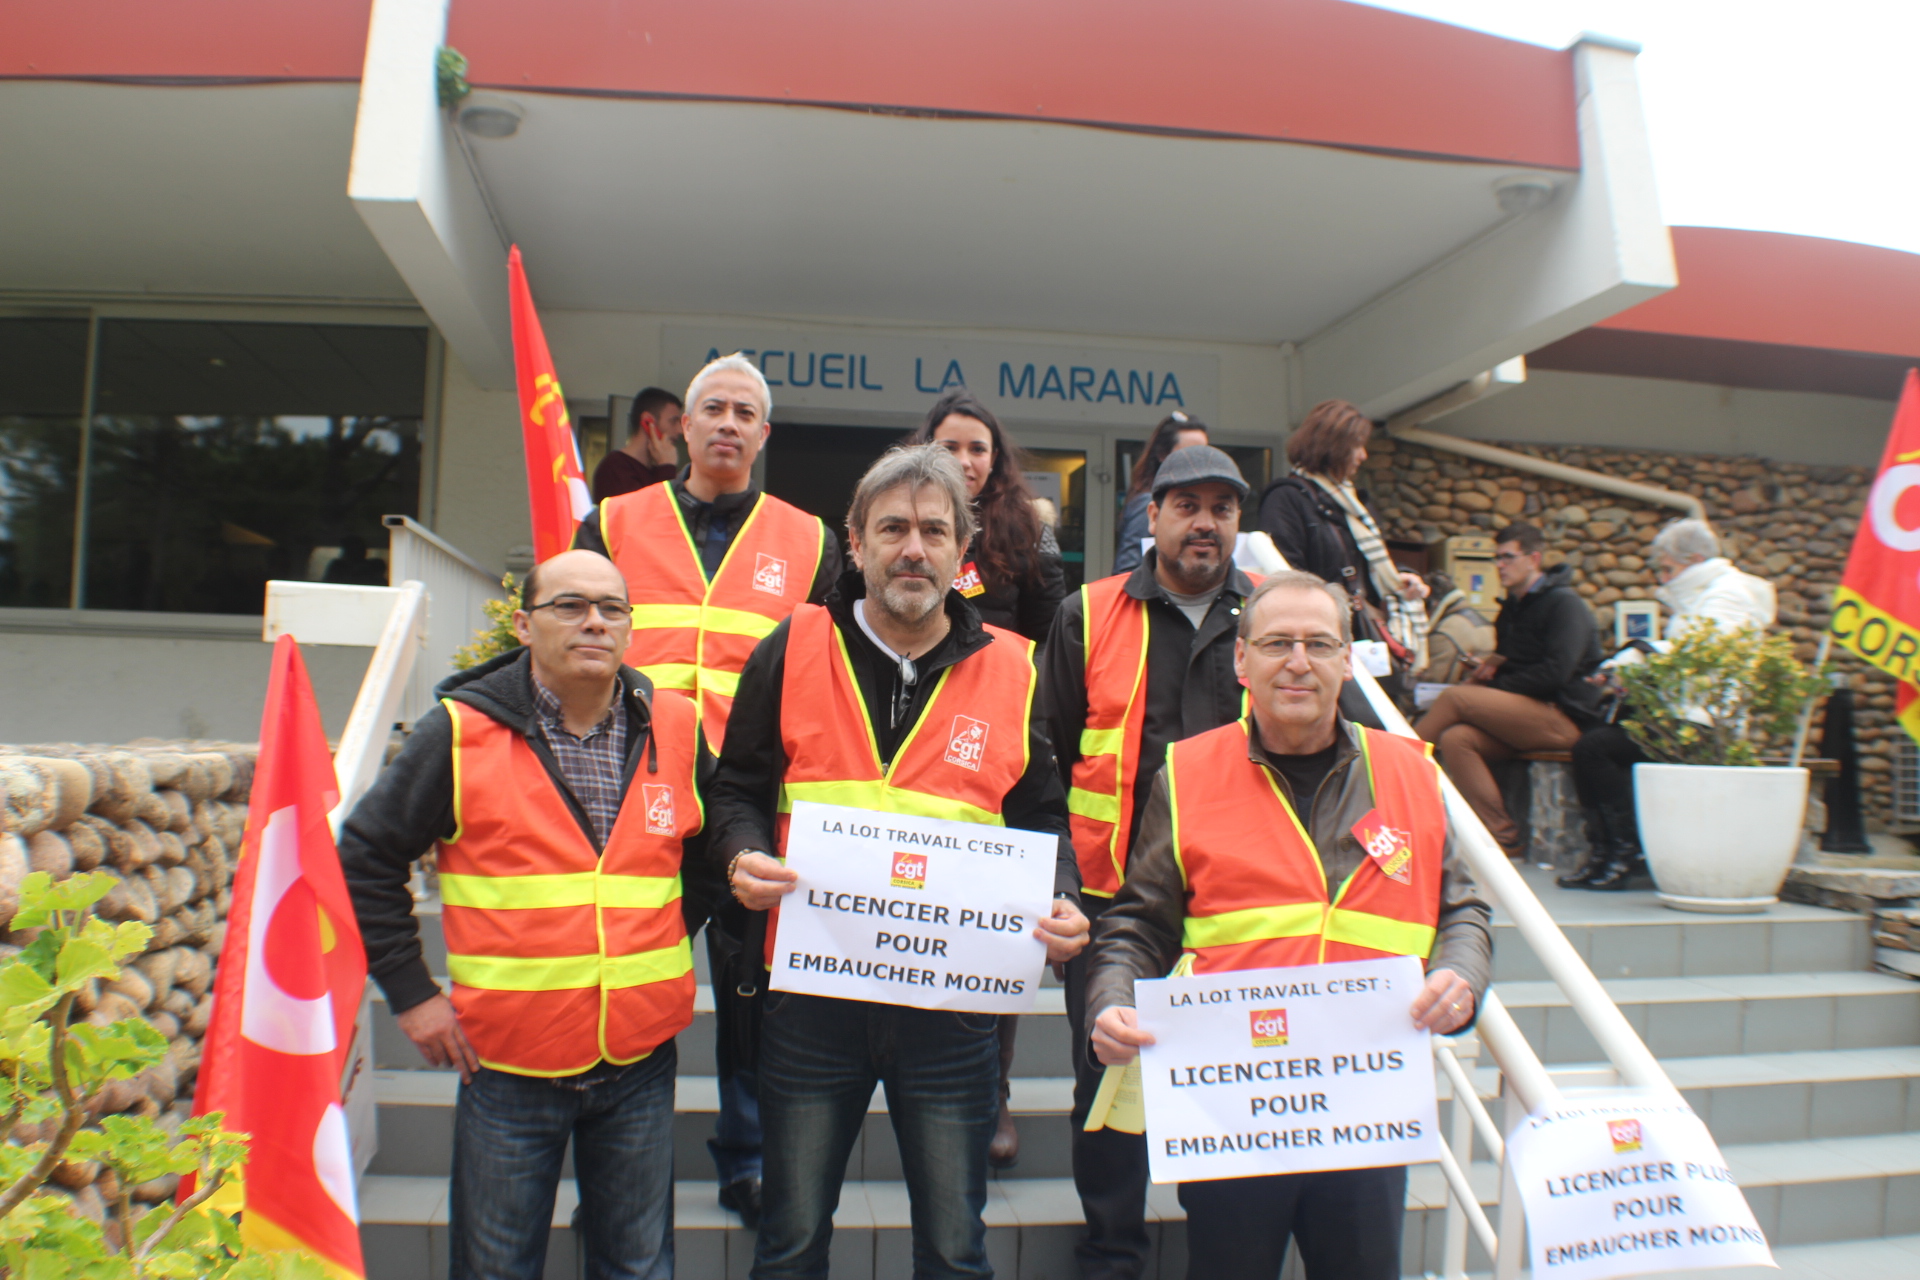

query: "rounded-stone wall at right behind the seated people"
xmin=1359 ymin=439 xmax=1905 ymax=819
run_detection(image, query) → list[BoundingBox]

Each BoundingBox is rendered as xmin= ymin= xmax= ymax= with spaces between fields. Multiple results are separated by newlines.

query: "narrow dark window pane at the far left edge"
xmin=0 ymin=319 xmax=86 ymax=608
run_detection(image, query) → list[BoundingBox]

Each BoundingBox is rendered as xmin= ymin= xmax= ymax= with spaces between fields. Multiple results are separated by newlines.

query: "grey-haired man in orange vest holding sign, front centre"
xmin=708 ymin=445 xmax=1087 ymax=1280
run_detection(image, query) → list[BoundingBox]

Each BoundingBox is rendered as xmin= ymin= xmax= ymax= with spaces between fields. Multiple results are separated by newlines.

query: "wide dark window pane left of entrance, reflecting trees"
xmin=84 ymin=320 xmax=426 ymax=614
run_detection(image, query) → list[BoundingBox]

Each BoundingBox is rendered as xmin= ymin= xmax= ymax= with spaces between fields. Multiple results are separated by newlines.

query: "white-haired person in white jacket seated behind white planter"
xmin=1557 ymin=520 xmax=1774 ymax=890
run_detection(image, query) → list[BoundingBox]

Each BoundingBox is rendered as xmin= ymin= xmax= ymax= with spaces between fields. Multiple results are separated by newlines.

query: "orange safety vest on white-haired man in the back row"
xmin=599 ymin=484 xmax=828 ymax=754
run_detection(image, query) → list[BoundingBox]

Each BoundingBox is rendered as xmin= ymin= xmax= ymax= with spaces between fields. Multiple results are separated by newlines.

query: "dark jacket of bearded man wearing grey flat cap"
xmin=1041 ymin=551 xmax=1254 ymax=848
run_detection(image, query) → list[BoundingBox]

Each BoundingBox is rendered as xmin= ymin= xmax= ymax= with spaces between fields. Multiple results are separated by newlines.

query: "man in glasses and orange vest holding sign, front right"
xmin=1079 ymin=570 xmax=1492 ymax=1280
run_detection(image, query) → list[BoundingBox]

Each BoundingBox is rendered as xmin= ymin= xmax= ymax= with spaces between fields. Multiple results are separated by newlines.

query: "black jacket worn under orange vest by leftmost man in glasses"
xmin=340 ymin=649 xmax=726 ymax=1013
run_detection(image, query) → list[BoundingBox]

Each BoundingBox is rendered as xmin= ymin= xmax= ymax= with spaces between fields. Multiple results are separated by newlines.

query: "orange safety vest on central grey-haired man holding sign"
xmin=766 ymin=604 xmax=1037 ymax=963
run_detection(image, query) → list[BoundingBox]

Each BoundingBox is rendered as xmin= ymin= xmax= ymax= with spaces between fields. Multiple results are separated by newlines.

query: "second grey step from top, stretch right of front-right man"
xmin=1496 ymin=971 xmax=1920 ymax=1063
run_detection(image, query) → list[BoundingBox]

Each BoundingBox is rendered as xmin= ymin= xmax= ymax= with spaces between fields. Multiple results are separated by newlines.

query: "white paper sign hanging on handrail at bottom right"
xmin=1507 ymin=1090 xmax=1776 ymax=1280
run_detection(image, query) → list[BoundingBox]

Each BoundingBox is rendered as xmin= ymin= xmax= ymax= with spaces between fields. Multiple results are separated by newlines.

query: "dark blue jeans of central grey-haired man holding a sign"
xmin=753 ymin=990 xmax=1000 ymax=1280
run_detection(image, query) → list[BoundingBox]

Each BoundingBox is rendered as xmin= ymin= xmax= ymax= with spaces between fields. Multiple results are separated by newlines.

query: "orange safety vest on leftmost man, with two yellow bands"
xmin=440 ymin=693 xmax=705 ymax=1077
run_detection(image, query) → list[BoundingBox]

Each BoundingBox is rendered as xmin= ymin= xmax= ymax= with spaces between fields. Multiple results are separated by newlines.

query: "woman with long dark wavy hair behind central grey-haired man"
xmin=908 ymin=391 xmax=1068 ymax=643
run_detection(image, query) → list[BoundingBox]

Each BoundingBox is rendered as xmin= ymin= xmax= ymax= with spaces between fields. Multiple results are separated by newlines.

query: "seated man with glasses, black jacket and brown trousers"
xmin=1415 ymin=524 xmax=1607 ymax=860
